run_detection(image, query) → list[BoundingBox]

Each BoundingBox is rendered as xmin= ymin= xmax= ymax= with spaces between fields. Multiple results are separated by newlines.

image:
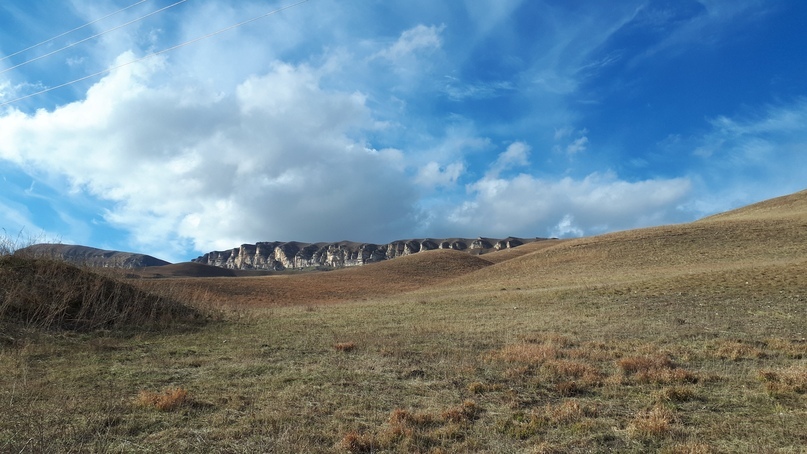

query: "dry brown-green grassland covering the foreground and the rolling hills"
xmin=0 ymin=191 xmax=807 ymax=453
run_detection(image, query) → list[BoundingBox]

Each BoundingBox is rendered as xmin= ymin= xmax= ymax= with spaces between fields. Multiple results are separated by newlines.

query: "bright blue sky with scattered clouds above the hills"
xmin=0 ymin=0 xmax=807 ymax=261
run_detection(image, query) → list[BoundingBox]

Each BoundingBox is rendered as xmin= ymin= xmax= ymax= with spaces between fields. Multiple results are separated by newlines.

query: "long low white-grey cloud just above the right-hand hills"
xmin=441 ymin=167 xmax=692 ymax=237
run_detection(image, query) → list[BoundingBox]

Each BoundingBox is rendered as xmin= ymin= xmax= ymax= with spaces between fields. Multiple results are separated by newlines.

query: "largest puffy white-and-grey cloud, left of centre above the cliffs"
xmin=0 ymin=56 xmax=415 ymax=258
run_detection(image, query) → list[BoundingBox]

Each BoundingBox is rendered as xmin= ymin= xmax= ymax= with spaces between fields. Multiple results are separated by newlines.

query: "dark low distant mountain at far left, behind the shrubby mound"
xmin=14 ymin=244 xmax=171 ymax=268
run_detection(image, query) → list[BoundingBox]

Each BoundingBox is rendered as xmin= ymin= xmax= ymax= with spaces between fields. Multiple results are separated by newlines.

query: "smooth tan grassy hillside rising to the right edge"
xmin=442 ymin=191 xmax=807 ymax=289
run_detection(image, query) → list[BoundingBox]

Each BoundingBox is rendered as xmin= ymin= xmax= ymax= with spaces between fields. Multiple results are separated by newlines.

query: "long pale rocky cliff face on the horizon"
xmin=193 ymin=237 xmax=536 ymax=271
